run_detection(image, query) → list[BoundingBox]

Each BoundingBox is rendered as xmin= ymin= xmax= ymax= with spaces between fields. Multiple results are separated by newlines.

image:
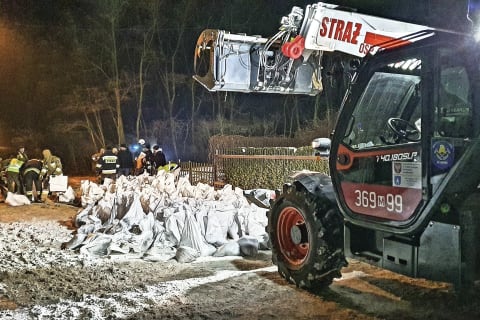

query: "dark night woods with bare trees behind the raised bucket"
xmin=0 ymin=0 xmax=475 ymax=174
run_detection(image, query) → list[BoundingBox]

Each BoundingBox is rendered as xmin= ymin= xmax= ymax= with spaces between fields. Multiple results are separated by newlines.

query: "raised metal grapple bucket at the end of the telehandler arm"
xmin=193 ymin=29 xmax=322 ymax=95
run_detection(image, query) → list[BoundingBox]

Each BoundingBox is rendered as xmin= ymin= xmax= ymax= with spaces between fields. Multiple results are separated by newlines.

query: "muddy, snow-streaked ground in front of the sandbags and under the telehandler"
xmin=0 ymin=176 xmax=480 ymax=320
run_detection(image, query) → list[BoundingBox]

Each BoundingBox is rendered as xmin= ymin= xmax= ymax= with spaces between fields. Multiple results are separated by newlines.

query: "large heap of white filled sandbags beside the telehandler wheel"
xmin=64 ymin=170 xmax=268 ymax=262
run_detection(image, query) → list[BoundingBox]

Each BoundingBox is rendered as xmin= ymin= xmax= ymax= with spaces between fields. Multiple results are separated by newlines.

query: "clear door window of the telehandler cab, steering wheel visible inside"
xmin=343 ymin=59 xmax=421 ymax=150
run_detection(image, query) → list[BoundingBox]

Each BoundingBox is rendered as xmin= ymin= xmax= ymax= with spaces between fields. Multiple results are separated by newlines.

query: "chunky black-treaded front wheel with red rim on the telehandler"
xmin=267 ymin=184 xmax=347 ymax=291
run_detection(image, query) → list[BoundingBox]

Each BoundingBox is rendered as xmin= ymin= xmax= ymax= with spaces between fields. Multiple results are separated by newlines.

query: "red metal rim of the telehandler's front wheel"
xmin=277 ymin=207 xmax=310 ymax=269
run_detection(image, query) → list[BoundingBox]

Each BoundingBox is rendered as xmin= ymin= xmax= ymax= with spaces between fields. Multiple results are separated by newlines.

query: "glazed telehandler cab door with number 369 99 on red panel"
xmin=333 ymin=55 xmax=425 ymax=225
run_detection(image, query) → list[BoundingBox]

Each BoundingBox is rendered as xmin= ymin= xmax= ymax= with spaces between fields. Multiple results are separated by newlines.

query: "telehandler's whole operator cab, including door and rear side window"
xmin=330 ymin=41 xmax=480 ymax=232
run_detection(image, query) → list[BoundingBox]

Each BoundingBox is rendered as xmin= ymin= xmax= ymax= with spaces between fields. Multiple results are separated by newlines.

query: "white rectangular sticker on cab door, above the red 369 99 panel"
xmin=392 ymin=161 xmax=422 ymax=189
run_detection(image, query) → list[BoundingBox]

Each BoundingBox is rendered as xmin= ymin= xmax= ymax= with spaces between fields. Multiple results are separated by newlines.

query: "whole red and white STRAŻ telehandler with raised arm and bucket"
xmin=194 ymin=2 xmax=480 ymax=290
